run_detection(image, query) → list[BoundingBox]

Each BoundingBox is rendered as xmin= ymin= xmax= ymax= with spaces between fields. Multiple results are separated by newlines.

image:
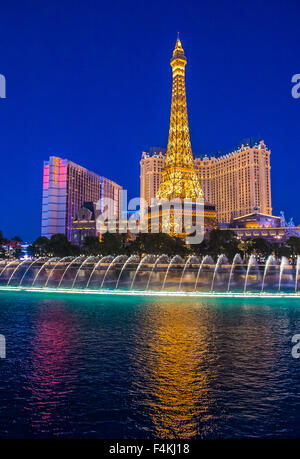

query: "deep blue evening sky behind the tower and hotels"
xmin=0 ymin=0 xmax=300 ymax=240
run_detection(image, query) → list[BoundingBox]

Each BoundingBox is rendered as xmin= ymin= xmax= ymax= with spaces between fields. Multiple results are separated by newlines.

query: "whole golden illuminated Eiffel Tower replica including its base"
xmin=147 ymin=37 xmax=204 ymax=237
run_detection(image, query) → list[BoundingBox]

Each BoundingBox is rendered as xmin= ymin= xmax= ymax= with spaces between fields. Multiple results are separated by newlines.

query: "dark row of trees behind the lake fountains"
xmin=28 ymin=229 xmax=300 ymax=260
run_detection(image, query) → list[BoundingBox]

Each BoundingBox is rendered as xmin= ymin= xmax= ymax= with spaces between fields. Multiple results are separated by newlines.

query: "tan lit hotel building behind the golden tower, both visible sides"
xmin=140 ymin=141 xmax=272 ymax=223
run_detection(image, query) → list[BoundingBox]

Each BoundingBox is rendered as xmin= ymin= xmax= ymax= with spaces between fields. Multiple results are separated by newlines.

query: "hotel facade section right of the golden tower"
xmin=195 ymin=141 xmax=272 ymax=222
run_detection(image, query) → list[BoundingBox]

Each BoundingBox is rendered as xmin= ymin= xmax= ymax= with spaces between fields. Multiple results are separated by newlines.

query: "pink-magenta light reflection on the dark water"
xmin=25 ymin=301 xmax=77 ymax=435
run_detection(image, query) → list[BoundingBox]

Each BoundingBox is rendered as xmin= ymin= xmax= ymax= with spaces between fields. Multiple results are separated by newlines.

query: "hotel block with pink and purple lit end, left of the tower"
xmin=42 ymin=156 xmax=122 ymax=240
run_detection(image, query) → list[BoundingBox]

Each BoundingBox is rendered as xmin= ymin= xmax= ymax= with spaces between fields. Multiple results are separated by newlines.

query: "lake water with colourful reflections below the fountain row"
xmin=0 ymin=292 xmax=300 ymax=438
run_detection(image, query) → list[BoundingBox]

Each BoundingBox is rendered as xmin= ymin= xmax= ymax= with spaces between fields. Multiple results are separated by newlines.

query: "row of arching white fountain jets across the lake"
xmin=0 ymin=254 xmax=300 ymax=298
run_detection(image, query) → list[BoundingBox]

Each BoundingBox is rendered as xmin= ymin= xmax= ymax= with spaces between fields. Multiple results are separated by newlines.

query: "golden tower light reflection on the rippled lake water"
xmin=134 ymin=303 xmax=214 ymax=439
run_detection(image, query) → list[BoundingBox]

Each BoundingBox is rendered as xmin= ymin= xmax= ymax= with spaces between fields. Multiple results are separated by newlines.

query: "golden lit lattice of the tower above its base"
xmin=156 ymin=37 xmax=203 ymax=201
